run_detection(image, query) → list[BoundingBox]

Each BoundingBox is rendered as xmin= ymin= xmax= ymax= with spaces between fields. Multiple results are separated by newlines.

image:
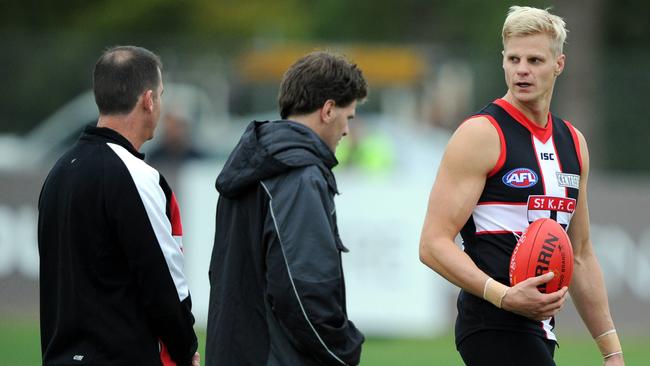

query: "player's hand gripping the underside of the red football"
xmin=501 ymin=272 xmax=569 ymax=321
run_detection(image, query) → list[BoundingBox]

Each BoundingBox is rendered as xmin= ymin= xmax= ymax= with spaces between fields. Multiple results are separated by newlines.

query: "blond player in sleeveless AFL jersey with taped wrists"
xmin=420 ymin=6 xmax=624 ymax=366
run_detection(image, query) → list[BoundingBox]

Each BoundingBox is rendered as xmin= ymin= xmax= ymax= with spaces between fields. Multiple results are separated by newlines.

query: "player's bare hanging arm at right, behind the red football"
xmin=568 ymin=133 xmax=623 ymax=365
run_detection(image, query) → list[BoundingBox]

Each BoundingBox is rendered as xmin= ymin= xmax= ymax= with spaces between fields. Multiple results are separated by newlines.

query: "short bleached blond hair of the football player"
xmin=501 ymin=6 xmax=568 ymax=56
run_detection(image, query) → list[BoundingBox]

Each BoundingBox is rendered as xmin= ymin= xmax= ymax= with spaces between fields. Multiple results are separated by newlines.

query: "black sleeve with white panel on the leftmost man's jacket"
xmin=107 ymin=161 xmax=198 ymax=366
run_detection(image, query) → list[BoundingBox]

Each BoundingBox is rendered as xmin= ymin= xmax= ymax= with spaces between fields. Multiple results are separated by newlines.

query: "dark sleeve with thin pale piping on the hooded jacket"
xmin=265 ymin=170 xmax=364 ymax=365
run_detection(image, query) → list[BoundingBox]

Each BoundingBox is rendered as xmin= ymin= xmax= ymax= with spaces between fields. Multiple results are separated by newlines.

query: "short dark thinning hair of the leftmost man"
xmin=93 ymin=46 xmax=162 ymax=115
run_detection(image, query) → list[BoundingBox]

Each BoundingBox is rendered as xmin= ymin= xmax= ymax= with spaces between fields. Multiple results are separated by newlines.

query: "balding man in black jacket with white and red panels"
xmin=38 ymin=46 xmax=199 ymax=366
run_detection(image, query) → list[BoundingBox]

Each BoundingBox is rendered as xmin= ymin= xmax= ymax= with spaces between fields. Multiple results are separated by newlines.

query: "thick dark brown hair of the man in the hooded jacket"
xmin=278 ymin=51 xmax=368 ymax=119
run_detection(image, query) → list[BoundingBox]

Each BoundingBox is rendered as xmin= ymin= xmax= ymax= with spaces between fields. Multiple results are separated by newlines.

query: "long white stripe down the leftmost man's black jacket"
xmin=108 ymin=143 xmax=189 ymax=301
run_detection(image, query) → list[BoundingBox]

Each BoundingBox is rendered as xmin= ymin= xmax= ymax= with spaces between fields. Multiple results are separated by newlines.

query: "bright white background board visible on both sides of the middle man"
xmin=179 ymin=164 xmax=453 ymax=336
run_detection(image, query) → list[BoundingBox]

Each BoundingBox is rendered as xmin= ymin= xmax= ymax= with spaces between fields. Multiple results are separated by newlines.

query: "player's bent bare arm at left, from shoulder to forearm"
xmin=420 ymin=119 xmax=499 ymax=297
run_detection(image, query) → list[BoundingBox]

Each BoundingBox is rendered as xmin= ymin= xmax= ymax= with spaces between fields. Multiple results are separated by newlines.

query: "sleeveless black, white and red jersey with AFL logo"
xmin=456 ymin=99 xmax=582 ymax=344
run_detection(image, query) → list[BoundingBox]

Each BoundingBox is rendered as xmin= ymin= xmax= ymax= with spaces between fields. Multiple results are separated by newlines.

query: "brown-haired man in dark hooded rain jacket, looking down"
xmin=206 ymin=52 xmax=367 ymax=366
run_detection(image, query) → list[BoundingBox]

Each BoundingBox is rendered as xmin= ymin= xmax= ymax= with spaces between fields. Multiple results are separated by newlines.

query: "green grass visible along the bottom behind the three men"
xmin=0 ymin=319 xmax=650 ymax=366
